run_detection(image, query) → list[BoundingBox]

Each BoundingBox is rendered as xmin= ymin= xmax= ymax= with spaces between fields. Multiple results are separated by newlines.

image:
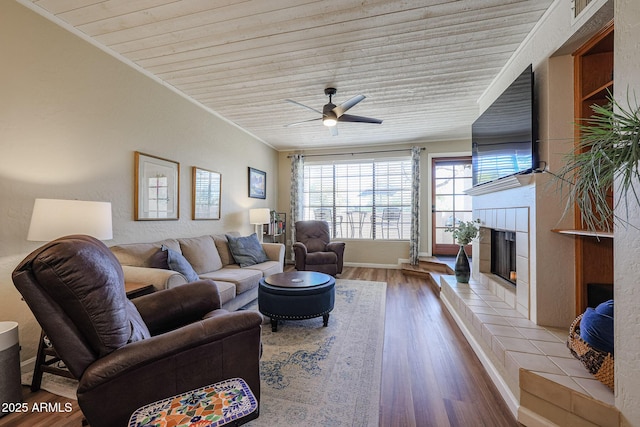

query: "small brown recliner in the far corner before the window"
xmin=293 ymin=221 xmax=345 ymax=277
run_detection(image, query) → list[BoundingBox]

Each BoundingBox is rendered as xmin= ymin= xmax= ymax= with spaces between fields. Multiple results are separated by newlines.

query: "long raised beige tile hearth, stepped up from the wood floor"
xmin=441 ymin=276 xmax=619 ymax=426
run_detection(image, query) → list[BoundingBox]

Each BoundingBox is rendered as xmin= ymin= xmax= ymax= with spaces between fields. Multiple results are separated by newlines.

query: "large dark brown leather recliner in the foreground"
xmin=13 ymin=235 xmax=262 ymax=427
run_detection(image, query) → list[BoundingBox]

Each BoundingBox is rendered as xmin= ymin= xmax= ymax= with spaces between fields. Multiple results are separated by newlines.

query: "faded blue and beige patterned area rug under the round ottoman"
xmin=247 ymin=279 xmax=386 ymax=427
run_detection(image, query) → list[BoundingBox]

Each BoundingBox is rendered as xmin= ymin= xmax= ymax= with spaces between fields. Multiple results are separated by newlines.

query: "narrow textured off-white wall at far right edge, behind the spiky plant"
xmin=614 ymin=0 xmax=640 ymax=426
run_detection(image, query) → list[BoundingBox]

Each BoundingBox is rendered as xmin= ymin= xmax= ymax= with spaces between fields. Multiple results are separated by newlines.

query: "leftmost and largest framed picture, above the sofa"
xmin=134 ymin=151 xmax=180 ymax=221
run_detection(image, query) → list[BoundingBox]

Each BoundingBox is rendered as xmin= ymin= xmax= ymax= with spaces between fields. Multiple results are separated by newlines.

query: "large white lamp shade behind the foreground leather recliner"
xmin=27 ymin=199 xmax=113 ymax=242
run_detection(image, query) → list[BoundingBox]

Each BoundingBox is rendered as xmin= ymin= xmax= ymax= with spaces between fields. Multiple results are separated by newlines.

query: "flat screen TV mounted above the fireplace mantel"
xmin=471 ymin=65 xmax=538 ymax=186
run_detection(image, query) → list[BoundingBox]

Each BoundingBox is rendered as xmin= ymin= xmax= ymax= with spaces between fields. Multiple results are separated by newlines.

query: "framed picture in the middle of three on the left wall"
xmin=191 ymin=166 xmax=222 ymax=219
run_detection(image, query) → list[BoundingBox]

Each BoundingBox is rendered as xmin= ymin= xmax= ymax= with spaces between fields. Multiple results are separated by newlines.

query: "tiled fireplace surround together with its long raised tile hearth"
xmin=441 ymin=174 xmax=619 ymax=426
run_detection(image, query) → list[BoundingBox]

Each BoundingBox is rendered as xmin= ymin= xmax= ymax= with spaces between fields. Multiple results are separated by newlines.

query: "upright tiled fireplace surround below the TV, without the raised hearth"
xmin=462 ymin=174 xmax=575 ymax=328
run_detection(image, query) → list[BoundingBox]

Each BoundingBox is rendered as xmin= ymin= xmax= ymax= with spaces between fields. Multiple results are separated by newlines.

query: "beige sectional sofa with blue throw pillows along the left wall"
xmin=110 ymin=232 xmax=285 ymax=311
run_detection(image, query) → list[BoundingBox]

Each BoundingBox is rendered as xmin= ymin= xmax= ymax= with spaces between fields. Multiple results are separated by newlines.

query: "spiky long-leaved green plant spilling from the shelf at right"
xmin=556 ymin=96 xmax=640 ymax=231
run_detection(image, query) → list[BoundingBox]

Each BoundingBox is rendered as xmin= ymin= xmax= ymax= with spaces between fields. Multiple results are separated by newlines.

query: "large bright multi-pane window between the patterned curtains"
xmin=303 ymin=158 xmax=411 ymax=240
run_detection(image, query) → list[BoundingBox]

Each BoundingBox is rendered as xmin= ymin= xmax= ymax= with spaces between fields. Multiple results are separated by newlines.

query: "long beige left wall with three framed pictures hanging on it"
xmin=0 ymin=1 xmax=278 ymax=360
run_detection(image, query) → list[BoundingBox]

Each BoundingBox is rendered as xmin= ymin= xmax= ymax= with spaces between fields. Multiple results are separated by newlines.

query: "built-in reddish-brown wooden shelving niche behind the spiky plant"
xmin=574 ymin=22 xmax=613 ymax=315
